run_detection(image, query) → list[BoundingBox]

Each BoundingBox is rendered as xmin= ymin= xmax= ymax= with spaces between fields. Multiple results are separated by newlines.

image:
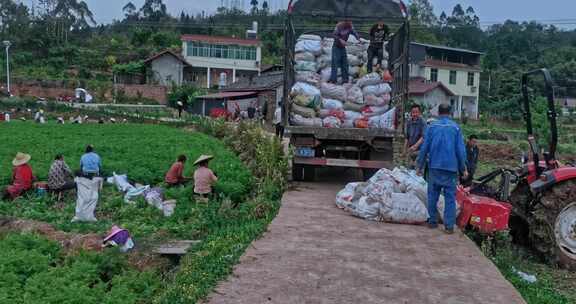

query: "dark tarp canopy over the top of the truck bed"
xmin=290 ymin=0 xmax=406 ymax=19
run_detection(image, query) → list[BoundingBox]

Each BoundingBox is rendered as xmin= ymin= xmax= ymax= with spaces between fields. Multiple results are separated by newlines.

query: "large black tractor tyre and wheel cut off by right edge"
xmin=530 ymin=180 xmax=576 ymax=270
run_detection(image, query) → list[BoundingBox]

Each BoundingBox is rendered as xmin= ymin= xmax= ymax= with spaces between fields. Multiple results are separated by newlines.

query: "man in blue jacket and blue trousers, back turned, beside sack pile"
xmin=418 ymin=104 xmax=468 ymax=234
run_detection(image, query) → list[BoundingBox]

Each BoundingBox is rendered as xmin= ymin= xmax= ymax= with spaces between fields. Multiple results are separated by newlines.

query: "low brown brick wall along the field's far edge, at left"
xmin=11 ymin=82 xmax=168 ymax=104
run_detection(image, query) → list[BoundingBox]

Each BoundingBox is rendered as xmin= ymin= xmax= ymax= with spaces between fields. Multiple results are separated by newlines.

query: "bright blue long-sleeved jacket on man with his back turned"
xmin=418 ymin=116 xmax=466 ymax=173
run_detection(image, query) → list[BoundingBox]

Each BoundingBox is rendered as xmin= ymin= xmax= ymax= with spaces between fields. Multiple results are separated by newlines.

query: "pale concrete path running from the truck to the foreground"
xmin=207 ymin=183 xmax=525 ymax=304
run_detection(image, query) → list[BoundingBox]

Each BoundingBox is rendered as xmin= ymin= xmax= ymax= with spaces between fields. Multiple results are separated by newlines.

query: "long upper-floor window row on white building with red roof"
xmin=186 ymin=42 xmax=256 ymax=60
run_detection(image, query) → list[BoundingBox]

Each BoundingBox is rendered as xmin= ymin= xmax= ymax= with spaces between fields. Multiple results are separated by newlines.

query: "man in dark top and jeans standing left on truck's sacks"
xmin=329 ymin=20 xmax=360 ymax=84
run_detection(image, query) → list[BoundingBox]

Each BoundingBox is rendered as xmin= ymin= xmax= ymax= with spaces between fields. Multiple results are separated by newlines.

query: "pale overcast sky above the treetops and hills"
xmin=23 ymin=0 xmax=576 ymax=27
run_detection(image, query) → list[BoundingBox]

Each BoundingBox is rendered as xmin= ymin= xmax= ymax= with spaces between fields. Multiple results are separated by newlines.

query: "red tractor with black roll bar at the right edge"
xmin=457 ymin=69 xmax=576 ymax=270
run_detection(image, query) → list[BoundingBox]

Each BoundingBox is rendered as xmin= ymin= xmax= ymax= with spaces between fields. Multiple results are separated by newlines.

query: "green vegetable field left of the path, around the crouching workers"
xmin=0 ymin=122 xmax=278 ymax=303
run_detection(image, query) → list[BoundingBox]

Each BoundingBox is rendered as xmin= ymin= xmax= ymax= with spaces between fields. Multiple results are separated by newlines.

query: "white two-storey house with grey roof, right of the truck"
xmin=410 ymin=42 xmax=483 ymax=119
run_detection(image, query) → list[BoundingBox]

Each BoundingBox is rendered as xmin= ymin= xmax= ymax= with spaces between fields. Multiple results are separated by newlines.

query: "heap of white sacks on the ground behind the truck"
xmin=336 ymin=168 xmax=460 ymax=224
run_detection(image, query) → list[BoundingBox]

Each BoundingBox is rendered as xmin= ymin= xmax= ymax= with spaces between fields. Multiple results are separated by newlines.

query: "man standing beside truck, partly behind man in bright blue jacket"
xmin=404 ymin=104 xmax=426 ymax=167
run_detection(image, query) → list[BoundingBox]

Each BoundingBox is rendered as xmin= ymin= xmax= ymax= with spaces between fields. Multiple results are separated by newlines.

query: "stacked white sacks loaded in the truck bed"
xmin=290 ymin=35 xmax=396 ymax=130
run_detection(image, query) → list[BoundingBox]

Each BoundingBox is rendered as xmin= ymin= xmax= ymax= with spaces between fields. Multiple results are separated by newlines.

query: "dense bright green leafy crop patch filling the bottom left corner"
xmin=0 ymin=233 xmax=161 ymax=304
